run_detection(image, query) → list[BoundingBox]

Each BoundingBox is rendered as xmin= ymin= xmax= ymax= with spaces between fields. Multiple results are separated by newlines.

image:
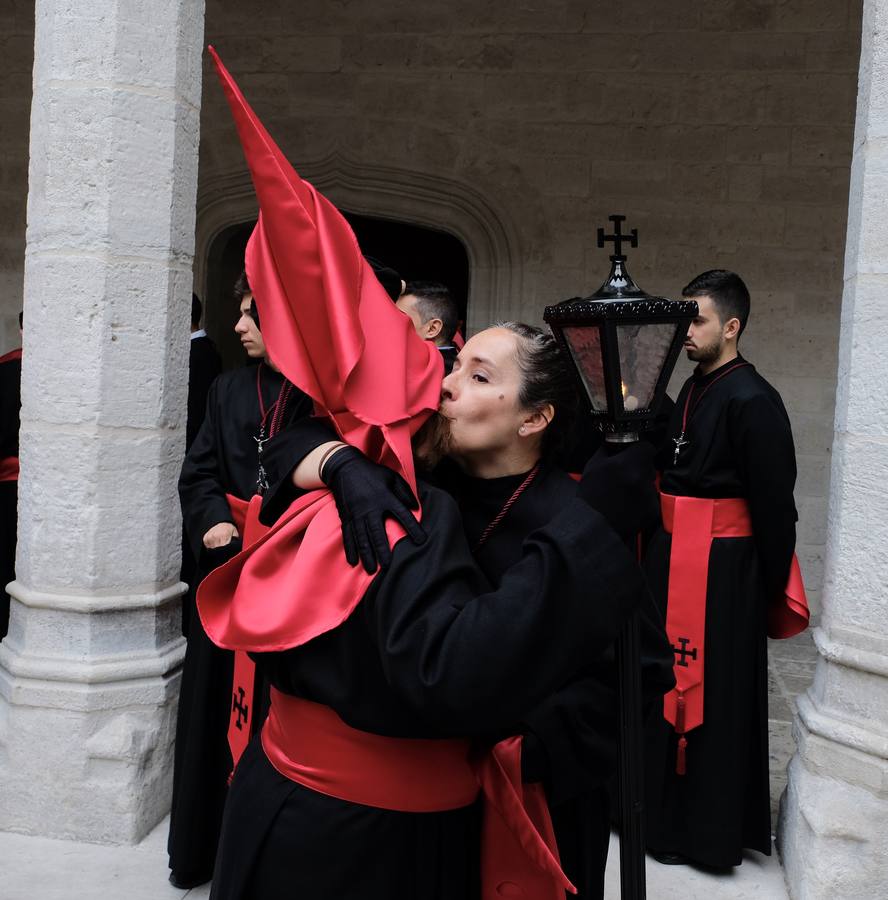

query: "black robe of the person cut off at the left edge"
xmin=0 ymin=348 xmax=22 ymax=640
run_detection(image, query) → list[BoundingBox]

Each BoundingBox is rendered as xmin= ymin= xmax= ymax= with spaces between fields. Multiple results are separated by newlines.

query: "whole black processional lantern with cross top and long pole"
xmin=543 ymin=216 xmax=698 ymax=900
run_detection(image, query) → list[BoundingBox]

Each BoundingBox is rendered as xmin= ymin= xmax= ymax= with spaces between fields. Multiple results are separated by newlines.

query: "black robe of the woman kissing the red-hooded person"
xmin=436 ymin=462 xmax=674 ymax=900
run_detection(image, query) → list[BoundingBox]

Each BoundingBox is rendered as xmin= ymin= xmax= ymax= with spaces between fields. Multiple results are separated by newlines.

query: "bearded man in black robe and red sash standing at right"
xmin=645 ymin=270 xmax=807 ymax=867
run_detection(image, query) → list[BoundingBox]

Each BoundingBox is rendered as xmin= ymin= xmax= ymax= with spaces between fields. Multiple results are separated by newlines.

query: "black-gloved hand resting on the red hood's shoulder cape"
xmin=321 ymin=447 xmax=426 ymax=573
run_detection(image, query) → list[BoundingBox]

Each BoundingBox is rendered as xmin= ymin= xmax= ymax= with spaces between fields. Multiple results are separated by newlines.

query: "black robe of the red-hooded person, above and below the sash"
xmin=211 ymin=485 xmax=644 ymax=900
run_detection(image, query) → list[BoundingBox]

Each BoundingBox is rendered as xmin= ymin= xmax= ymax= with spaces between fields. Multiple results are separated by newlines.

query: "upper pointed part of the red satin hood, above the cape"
xmin=209 ymin=47 xmax=443 ymax=485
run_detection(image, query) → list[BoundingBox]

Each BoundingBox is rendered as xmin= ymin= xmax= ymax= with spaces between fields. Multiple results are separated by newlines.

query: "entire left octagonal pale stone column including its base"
xmin=0 ymin=0 xmax=204 ymax=842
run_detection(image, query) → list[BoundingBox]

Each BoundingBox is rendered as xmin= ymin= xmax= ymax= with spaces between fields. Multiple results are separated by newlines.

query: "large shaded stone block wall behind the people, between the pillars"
xmin=198 ymin=0 xmax=861 ymax=607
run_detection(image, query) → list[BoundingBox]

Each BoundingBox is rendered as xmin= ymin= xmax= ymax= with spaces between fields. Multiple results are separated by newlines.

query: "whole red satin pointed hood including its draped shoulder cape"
xmin=197 ymin=48 xmax=443 ymax=651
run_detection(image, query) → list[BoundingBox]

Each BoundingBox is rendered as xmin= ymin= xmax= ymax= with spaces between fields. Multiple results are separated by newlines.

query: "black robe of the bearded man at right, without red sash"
xmin=645 ymin=354 xmax=797 ymax=867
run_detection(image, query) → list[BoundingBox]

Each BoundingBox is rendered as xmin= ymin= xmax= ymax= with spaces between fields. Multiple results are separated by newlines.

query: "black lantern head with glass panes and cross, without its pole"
xmin=543 ymin=216 xmax=697 ymax=441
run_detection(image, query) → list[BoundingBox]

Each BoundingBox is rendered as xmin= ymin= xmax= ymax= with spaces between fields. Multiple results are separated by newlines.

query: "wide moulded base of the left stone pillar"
xmin=0 ymin=582 xmax=185 ymax=844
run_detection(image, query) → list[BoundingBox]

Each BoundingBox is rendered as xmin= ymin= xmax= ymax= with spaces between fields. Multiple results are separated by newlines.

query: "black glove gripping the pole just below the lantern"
xmin=577 ymin=441 xmax=660 ymax=540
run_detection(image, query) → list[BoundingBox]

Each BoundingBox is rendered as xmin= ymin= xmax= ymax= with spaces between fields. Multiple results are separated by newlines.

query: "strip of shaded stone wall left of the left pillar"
xmin=0 ymin=0 xmax=34 ymax=355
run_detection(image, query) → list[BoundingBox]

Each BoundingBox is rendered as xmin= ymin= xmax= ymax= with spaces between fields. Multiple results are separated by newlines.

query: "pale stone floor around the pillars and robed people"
xmin=0 ymin=632 xmax=816 ymax=900
